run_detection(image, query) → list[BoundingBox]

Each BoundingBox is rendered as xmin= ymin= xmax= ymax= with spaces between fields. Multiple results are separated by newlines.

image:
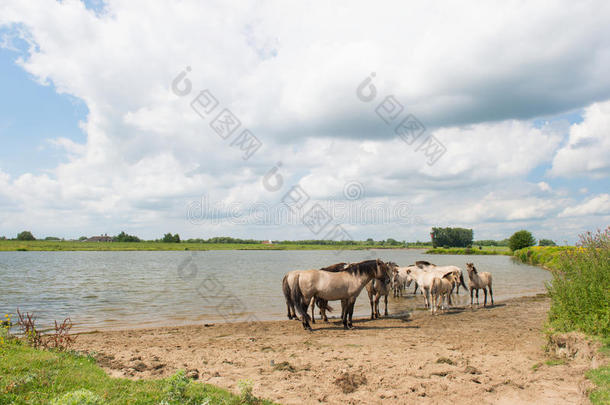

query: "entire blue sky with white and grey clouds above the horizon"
xmin=0 ymin=0 xmax=610 ymax=243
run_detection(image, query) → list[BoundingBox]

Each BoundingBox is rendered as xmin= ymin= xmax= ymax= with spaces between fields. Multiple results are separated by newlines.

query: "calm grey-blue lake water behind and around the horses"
xmin=0 ymin=250 xmax=550 ymax=331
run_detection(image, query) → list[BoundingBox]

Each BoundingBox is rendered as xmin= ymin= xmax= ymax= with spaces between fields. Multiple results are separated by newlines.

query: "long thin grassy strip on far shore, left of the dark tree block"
xmin=0 ymin=240 xmax=416 ymax=252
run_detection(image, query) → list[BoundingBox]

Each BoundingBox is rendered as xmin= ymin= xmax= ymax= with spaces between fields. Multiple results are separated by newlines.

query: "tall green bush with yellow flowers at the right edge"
xmin=547 ymin=227 xmax=610 ymax=336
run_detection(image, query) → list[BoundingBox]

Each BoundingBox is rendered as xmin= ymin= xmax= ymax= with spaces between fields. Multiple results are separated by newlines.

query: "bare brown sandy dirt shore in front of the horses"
xmin=76 ymin=296 xmax=595 ymax=404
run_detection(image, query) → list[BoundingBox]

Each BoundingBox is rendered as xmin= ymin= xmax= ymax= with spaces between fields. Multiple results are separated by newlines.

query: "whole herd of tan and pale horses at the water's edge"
xmin=282 ymin=259 xmax=494 ymax=330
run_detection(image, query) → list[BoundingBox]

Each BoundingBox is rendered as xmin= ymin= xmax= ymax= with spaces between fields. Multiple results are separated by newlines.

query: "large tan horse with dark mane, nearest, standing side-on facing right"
xmin=292 ymin=259 xmax=390 ymax=330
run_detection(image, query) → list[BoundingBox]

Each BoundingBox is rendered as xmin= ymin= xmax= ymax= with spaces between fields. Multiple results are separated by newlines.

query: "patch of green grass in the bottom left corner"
xmin=0 ymin=340 xmax=270 ymax=404
